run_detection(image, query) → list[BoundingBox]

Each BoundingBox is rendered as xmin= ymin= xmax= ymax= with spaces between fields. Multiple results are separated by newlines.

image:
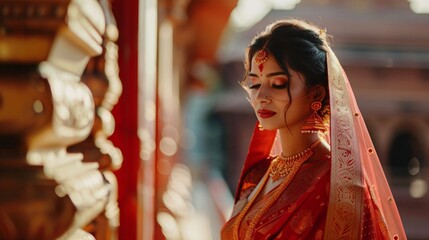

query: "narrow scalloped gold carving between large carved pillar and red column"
xmin=68 ymin=0 xmax=123 ymax=239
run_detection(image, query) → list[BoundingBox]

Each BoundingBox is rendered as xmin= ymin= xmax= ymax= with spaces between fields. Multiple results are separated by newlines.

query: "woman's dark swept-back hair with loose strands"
xmin=245 ymin=19 xmax=329 ymax=120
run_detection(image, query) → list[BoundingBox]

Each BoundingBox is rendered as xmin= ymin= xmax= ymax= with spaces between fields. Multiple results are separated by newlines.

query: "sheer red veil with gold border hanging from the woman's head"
xmin=236 ymin=47 xmax=406 ymax=239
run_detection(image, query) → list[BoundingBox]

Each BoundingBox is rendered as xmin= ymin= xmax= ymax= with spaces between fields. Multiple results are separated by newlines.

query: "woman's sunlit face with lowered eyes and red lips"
xmin=243 ymin=54 xmax=311 ymax=130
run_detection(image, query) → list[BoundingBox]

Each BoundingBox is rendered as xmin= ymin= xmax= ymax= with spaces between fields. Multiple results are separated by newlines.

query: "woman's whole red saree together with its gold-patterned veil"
xmin=221 ymin=47 xmax=406 ymax=240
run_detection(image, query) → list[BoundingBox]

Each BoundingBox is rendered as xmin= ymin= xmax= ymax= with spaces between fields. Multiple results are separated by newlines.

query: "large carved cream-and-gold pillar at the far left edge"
xmin=0 ymin=0 xmax=120 ymax=239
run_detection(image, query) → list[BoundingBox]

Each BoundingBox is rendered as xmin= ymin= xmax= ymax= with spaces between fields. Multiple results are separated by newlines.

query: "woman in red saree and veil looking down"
xmin=221 ymin=19 xmax=406 ymax=240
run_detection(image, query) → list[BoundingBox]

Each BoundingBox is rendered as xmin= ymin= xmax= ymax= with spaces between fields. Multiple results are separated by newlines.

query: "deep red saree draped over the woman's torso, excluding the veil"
xmin=222 ymin=153 xmax=330 ymax=239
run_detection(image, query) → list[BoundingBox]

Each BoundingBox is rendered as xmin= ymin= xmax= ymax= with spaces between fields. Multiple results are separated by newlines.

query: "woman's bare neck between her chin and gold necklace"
xmin=279 ymin=129 xmax=319 ymax=157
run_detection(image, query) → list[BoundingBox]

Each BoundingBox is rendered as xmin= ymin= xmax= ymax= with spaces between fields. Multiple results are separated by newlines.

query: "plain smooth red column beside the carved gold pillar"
xmin=111 ymin=0 xmax=140 ymax=240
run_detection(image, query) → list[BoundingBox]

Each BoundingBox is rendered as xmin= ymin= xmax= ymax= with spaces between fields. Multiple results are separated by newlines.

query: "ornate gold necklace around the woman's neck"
xmin=270 ymin=139 xmax=320 ymax=182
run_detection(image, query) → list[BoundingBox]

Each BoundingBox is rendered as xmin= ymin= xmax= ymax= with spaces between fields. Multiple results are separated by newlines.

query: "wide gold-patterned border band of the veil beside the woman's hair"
xmin=325 ymin=51 xmax=363 ymax=239
